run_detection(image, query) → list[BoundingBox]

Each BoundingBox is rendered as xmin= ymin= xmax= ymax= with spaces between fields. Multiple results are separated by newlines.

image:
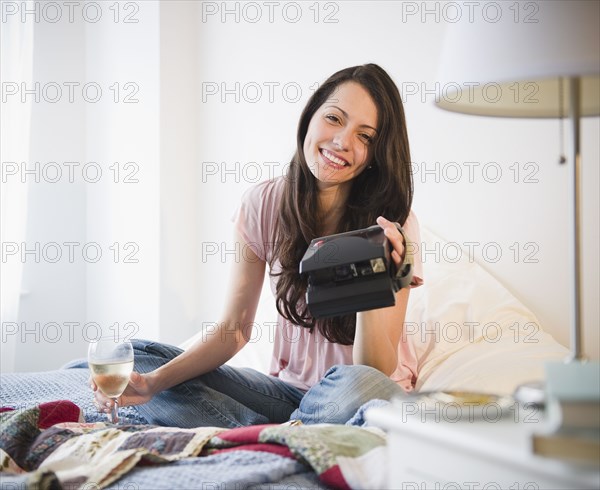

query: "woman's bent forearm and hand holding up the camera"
xmin=352 ymin=218 xmax=409 ymax=376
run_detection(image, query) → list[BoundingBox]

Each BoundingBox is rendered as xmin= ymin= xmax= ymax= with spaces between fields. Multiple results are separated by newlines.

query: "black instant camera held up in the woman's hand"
xmin=300 ymin=223 xmax=413 ymax=318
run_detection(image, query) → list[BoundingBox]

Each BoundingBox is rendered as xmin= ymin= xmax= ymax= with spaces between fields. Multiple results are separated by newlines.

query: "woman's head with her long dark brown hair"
xmin=270 ymin=64 xmax=414 ymax=345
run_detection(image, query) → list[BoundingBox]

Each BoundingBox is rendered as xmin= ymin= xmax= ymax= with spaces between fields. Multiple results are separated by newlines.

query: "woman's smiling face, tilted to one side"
xmin=304 ymin=82 xmax=377 ymax=189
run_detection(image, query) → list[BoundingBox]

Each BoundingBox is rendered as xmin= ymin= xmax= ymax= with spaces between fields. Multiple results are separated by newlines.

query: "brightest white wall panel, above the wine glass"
xmin=85 ymin=2 xmax=161 ymax=346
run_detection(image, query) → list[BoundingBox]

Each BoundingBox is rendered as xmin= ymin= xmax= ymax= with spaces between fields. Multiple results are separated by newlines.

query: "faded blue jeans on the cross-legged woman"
xmin=118 ymin=340 xmax=403 ymax=427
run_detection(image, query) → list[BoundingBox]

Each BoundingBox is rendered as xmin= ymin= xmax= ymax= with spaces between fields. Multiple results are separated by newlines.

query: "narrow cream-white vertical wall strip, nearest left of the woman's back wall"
xmin=159 ymin=2 xmax=202 ymax=344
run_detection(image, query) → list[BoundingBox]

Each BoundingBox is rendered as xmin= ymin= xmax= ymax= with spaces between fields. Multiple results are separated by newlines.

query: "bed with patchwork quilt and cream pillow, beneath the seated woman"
xmin=0 ymin=228 xmax=568 ymax=490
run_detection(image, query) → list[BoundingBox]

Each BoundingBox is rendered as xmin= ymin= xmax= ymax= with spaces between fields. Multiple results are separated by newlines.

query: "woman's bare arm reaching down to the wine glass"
xmin=92 ymin=233 xmax=265 ymax=407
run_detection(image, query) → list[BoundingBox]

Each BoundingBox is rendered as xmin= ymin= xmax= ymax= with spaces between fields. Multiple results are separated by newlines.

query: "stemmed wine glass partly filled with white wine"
xmin=88 ymin=337 xmax=133 ymax=424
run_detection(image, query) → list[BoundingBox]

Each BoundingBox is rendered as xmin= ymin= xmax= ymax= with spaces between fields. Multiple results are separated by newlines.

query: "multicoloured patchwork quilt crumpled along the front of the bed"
xmin=0 ymin=400 xmax=385 ymax=490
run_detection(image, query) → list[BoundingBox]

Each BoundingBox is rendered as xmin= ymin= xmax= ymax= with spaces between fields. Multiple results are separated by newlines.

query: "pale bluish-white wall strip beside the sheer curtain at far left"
xmin=7 ymin=13 xmax=86 ymax=371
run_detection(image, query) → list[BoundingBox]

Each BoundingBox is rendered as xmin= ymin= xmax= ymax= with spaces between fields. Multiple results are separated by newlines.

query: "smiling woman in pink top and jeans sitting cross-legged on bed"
xmin=92 ymin=64 xmax=422 ymax=427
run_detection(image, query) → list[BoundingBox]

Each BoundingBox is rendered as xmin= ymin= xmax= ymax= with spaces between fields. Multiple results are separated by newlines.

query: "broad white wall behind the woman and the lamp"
xmin=198 ymin=2 xmax=599 ymax=358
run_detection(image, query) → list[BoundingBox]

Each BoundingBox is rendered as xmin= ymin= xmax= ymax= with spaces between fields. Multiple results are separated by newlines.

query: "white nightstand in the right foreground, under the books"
xmin=366 ymin=401 xmax=600 ymax=490
